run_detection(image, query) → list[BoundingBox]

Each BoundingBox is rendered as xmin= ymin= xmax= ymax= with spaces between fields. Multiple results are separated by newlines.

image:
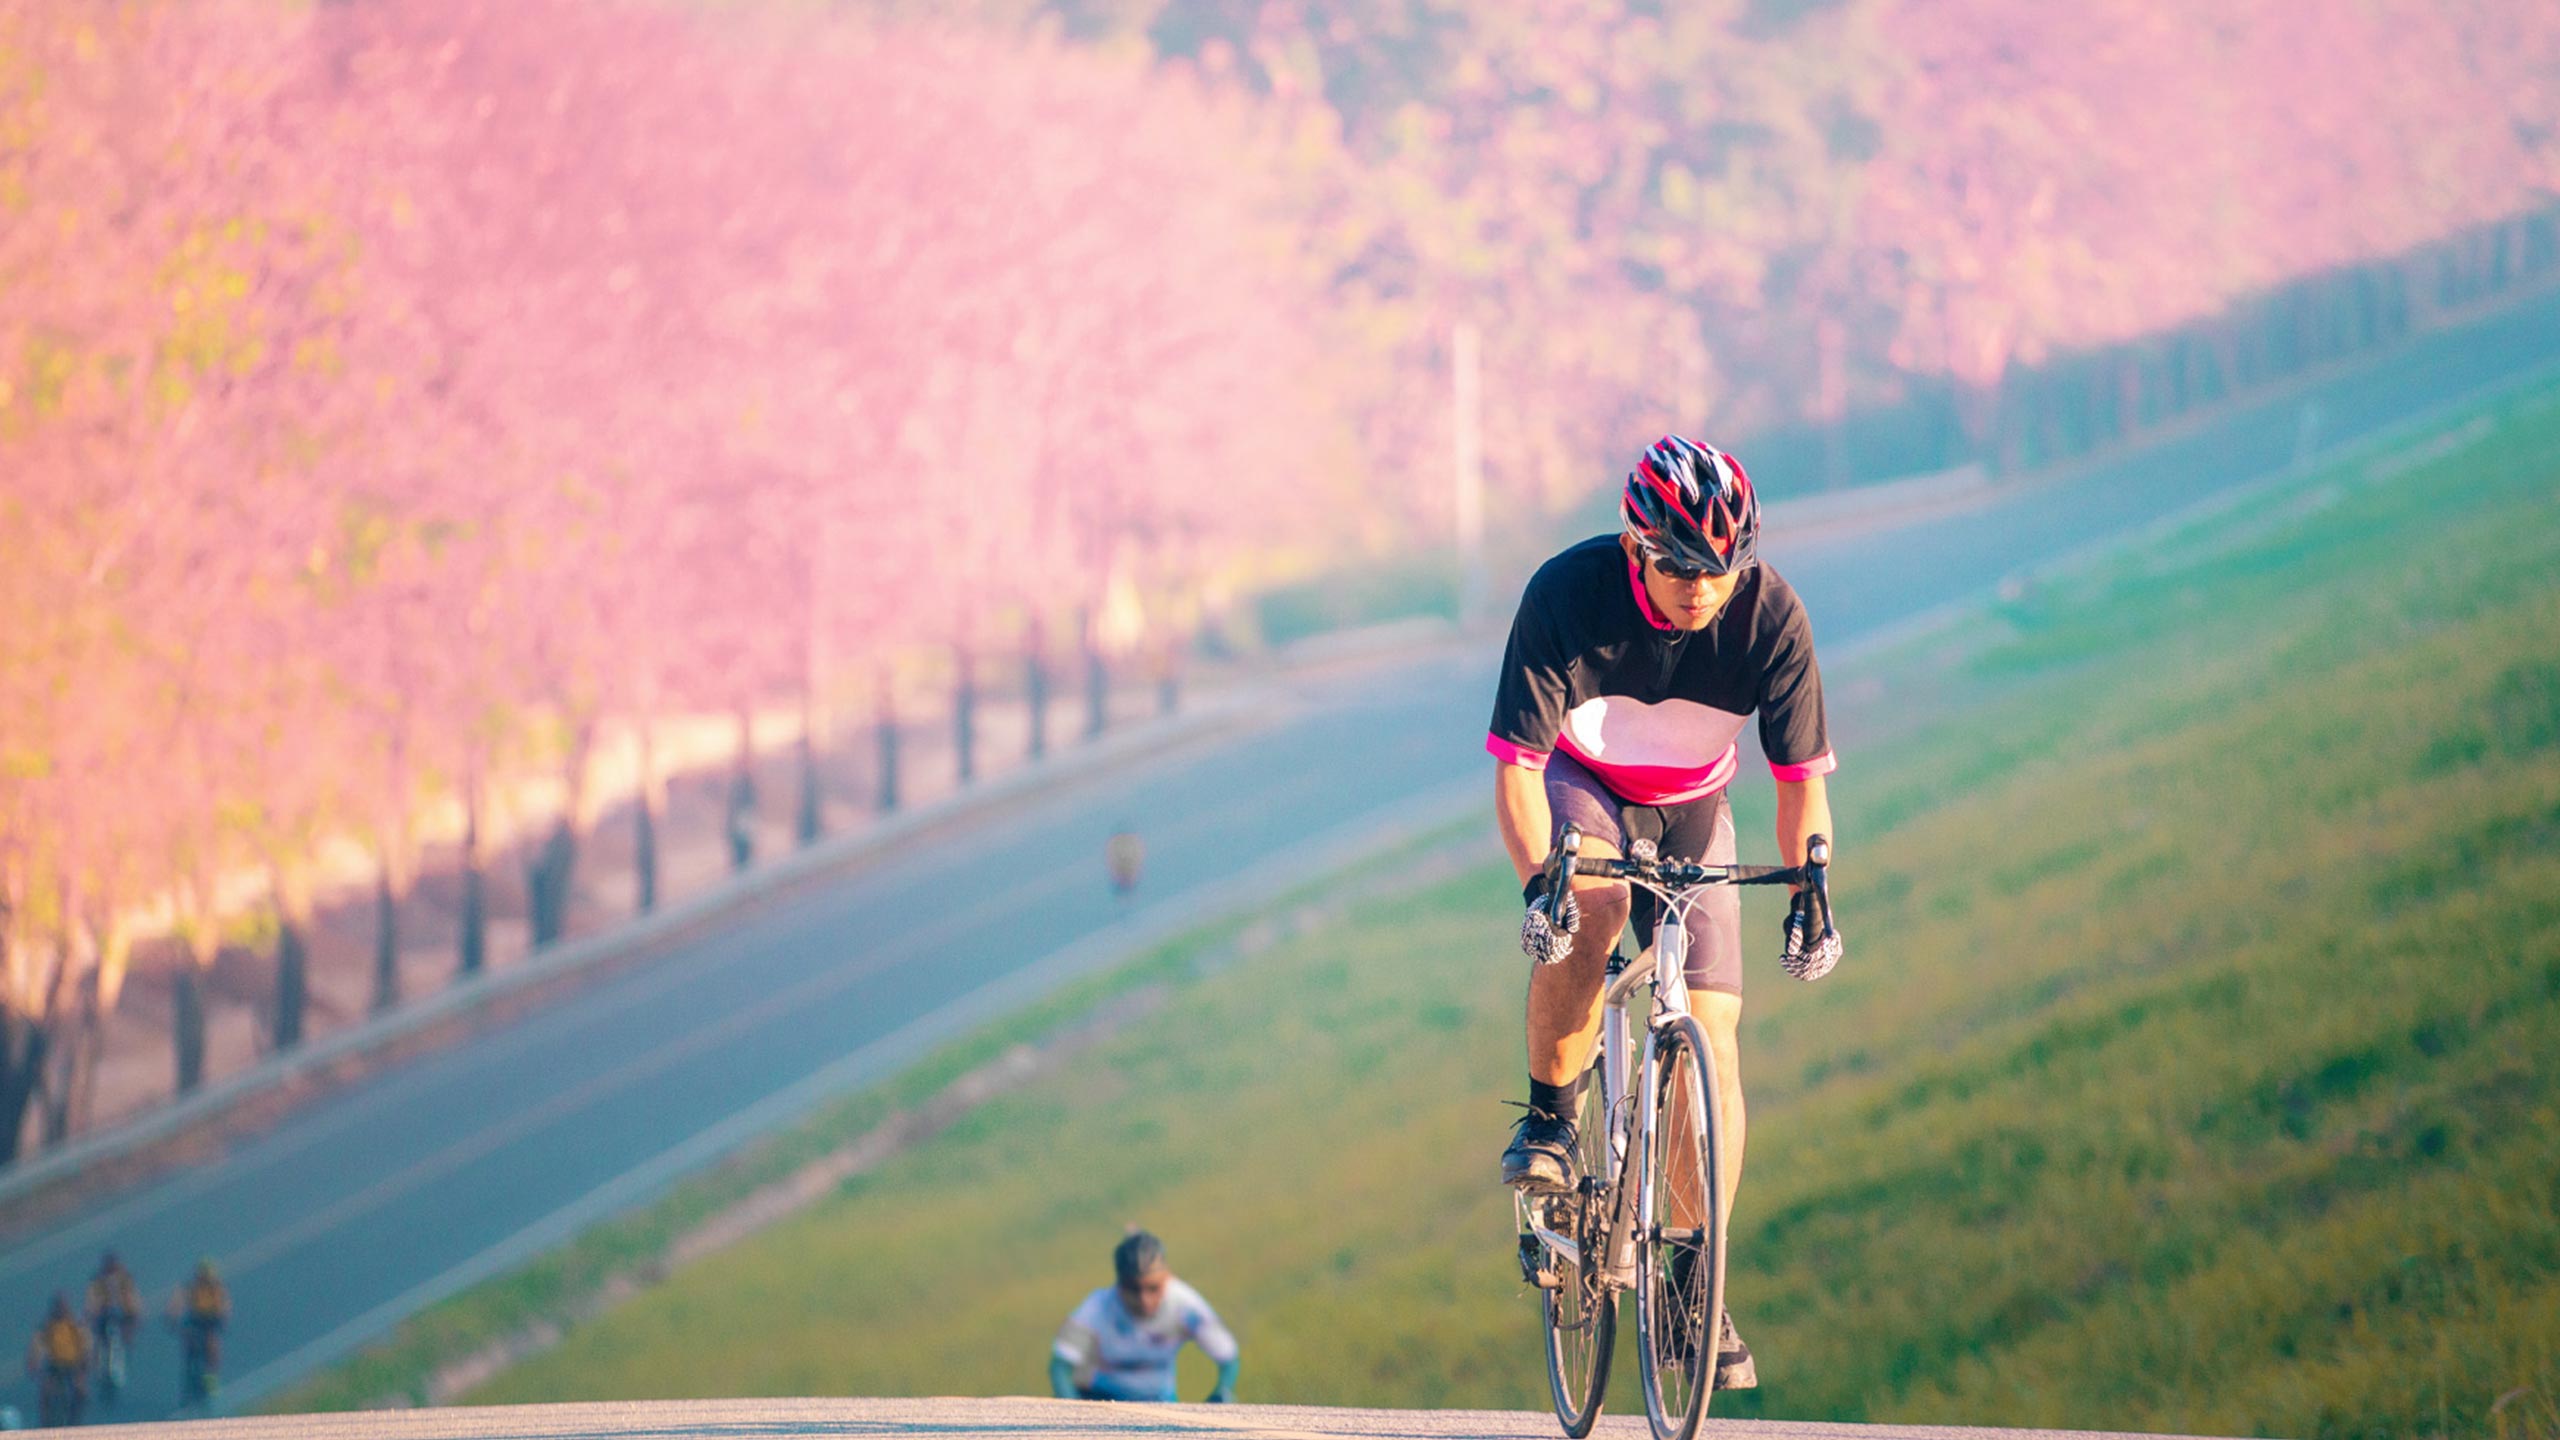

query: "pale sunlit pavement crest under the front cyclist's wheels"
xmin=49 ymin=1399 xmax=2232 ymax=1440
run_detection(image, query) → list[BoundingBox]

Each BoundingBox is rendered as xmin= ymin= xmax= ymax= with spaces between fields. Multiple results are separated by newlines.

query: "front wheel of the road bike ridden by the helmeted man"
xmin=1636 ymin=1015 xmax=1725 ymax=1440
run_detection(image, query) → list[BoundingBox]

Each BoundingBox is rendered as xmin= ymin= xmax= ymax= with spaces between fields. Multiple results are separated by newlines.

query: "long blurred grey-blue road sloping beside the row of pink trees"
xmin=0 ymin=285 xmax=2560 ymax=1417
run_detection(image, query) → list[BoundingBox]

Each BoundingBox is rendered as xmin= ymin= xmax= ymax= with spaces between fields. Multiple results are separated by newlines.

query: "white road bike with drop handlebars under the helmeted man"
xmin=1513 ymin=825 xmax=1830 ymax=1440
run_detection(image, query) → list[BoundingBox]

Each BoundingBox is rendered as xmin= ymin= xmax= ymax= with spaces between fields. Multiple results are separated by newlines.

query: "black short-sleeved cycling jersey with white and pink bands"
xmin=1485 ymin=536 xmax=1836 ymax=805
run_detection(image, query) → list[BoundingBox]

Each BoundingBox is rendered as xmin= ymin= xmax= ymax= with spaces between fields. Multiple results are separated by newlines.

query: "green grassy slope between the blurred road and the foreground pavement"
xmin=300 ymin=381 xmax=2560 ymax=1437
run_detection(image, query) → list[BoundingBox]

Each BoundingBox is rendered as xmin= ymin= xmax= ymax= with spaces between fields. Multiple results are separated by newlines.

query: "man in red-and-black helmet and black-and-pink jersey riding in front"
xmin=1485 ymin=436 xmax=1838 ymax=1389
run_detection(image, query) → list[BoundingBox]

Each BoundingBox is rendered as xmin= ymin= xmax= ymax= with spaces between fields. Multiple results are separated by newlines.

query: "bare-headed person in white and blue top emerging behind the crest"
xmin=1050 ymin=1230 xmax=1239 ymax=1404
